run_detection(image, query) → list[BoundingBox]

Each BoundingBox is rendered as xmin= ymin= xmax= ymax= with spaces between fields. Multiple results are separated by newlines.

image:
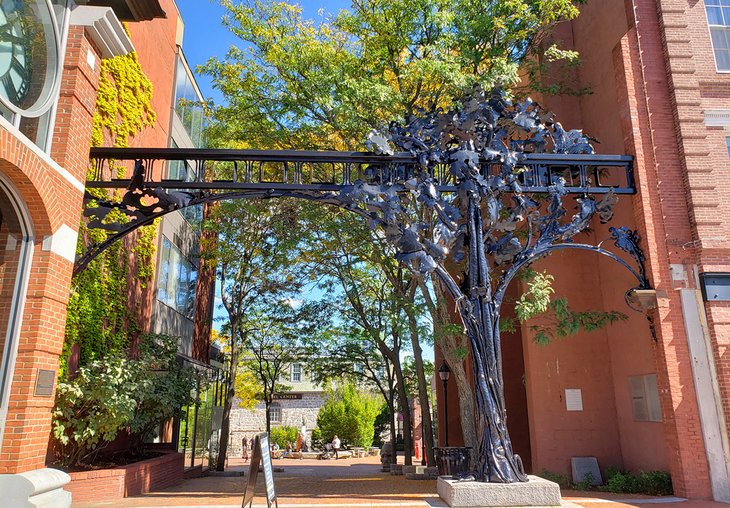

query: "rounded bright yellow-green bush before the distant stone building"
xmin=317 ymin=382 xmax=382 ymax=448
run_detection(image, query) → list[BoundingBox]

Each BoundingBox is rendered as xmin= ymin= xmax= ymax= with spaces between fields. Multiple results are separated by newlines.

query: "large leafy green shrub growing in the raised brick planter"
xmin=52 ymin=335 xmax=195 ymax=466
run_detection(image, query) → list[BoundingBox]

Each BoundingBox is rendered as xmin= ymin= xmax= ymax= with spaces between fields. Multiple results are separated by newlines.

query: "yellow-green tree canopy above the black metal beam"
xmin=203 ymin=0 xmax=581 ymax=149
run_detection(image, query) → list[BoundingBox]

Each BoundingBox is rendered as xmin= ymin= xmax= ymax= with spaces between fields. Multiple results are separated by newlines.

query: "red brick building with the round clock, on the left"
xmin=0 ymin=0 xmax=212 ymax=502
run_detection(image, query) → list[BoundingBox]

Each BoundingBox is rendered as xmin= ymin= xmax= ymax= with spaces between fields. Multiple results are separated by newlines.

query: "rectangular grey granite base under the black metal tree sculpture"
xmin=436 ymin=476 xmax=560 ymax=508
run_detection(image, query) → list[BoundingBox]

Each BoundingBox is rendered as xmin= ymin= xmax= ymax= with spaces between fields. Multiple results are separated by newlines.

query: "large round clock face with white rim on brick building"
xmin=0 ymin=0 xmax=58 ymax=116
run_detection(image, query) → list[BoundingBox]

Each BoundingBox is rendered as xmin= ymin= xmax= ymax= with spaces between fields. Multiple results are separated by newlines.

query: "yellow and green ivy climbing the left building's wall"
xmin=61 ymin=53 xmax=157 ymax=376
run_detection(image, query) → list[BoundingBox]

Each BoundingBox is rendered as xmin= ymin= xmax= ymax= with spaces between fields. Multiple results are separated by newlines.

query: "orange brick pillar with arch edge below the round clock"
xmin=0 ymin=27 xmax=100 ymax=474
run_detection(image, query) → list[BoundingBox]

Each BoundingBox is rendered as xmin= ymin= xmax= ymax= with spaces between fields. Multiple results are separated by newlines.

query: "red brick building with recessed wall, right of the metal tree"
xmin=439 ymin=0 xmax=730 ymax=502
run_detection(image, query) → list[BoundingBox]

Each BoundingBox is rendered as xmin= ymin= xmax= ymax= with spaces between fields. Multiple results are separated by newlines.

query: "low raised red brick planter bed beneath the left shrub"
xmin=64 ymin=453 xmax=184 ymax=503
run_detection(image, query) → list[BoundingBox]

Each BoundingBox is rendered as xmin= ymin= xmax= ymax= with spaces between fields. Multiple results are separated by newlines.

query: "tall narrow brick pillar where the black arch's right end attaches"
xmin=614 ymin=8 xmax=712 ymax=498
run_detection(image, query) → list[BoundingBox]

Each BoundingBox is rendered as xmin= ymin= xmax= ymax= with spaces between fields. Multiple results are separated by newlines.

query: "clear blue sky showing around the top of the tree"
xmin=175 ymin=0 xmax=350 ymax=104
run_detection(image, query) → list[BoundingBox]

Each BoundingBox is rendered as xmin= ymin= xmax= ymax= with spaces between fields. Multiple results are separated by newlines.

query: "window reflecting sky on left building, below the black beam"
xmin=157 ymin=236 xmax=198 ymax=319
